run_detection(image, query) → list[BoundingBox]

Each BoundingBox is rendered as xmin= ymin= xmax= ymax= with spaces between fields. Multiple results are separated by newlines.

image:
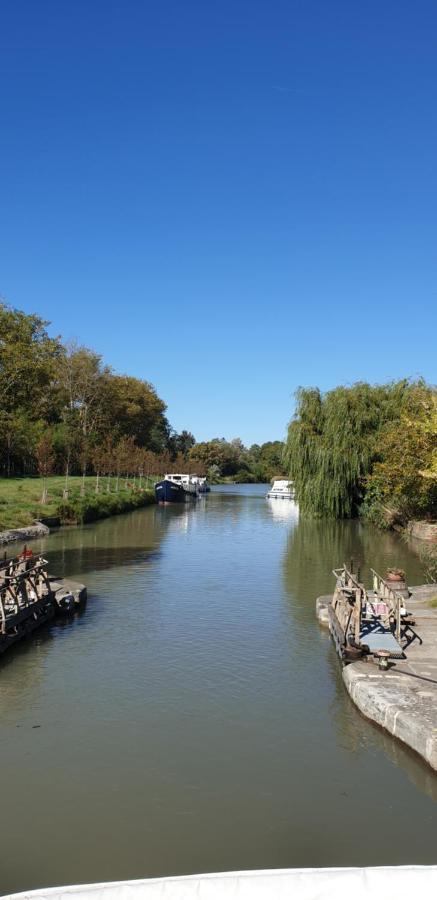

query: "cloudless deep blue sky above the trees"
xmin=0 ymin=0 xmax=437 ymax=443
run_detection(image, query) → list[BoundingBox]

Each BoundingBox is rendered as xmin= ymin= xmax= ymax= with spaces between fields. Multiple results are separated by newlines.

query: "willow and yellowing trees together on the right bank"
xmin=285 ymin=380 xmax=437 ymax=527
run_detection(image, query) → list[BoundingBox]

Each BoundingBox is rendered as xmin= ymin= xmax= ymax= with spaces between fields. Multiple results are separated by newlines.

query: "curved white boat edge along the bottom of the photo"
xmin=5 ymin=866 xmax=437 ymax=900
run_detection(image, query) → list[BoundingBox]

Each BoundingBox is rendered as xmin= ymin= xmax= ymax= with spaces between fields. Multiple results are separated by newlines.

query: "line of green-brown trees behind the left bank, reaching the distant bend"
xmin=0 ymin=302 xmax=283 ymax=486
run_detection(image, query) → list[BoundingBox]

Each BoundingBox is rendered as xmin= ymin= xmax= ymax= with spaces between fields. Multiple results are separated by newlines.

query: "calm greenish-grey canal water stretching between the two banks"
xmin=0 ymin=485 xmax=437 ymax=894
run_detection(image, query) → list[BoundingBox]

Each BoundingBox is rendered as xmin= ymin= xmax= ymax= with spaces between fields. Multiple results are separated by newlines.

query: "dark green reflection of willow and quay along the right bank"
xmin=283 ymin=518 xmax=437 ymax=801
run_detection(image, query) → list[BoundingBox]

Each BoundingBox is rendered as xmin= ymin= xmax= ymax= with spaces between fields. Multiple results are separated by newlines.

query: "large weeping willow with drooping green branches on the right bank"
xmin=285 ymin=380 xmax=412 ymax=519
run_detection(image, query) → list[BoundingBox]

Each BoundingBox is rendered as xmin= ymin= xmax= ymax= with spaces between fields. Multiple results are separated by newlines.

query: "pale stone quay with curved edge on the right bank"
xmin=316 ymin=584 xmax=437 ymax=771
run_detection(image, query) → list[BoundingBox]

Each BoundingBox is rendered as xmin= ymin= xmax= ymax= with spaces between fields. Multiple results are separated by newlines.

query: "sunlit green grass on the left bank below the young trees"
xmin=0 ymin=475 xmax=157 ymax=531
